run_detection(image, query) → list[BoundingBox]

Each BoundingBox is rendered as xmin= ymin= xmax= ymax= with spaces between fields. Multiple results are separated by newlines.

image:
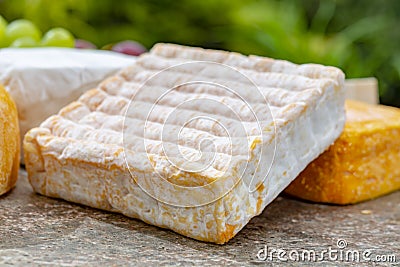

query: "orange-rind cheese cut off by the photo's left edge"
xmin=0 ymin=85 xmax=20 ymax=195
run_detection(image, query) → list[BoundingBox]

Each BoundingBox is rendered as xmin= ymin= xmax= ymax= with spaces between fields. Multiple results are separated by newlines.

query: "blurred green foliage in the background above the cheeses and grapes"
xmin=0 ymin=0 xmax=400 ymax=106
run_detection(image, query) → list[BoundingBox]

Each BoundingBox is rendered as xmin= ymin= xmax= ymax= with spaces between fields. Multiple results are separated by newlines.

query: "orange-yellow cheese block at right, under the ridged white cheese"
xmin=286 ymin=100 xmax=400 ymax=204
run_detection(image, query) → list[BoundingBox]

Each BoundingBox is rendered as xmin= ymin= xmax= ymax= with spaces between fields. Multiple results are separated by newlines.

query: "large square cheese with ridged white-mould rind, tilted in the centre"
xmin=24 ymin=44 xmax=345 ymax=244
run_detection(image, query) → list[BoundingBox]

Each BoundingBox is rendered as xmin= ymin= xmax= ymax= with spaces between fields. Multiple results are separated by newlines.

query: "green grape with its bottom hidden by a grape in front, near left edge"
xmin=6 ymin=19 xmax=42 ymax=45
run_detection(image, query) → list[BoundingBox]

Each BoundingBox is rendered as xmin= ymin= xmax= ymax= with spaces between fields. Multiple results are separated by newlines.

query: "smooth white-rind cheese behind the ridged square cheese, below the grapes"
xmin=0 ymin=48 xmax=135 ymax=144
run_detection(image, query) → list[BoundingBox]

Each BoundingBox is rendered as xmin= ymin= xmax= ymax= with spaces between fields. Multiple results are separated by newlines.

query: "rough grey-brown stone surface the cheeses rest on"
xmin=0 ymin=171 xmax=400 ymax=266
